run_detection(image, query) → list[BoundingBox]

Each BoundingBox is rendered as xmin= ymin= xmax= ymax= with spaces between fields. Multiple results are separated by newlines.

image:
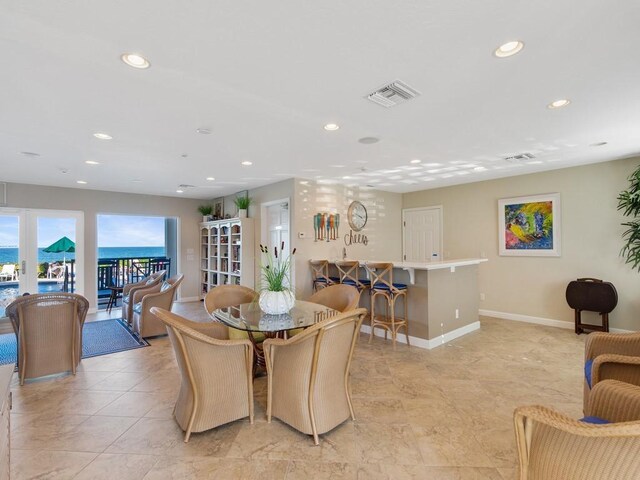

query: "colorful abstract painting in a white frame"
xmin=498 ymin=193 xmax=560 ymax=256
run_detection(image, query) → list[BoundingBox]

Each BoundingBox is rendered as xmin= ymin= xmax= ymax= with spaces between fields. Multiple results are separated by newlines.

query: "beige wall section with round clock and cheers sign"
xmin=292 ymin=179 xmax=402 ymax=298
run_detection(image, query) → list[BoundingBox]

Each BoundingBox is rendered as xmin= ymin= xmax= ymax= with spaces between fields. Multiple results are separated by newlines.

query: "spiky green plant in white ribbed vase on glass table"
xmin=258 ymin=242 xmax=296 ymax=315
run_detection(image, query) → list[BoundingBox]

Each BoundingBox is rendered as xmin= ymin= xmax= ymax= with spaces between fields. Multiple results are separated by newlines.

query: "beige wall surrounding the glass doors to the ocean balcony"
xmin=1 ymin=183 xmax=202 ymax=307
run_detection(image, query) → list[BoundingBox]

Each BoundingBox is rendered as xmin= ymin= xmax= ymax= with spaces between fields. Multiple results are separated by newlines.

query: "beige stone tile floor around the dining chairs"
xmin=11 ymin=302 xmax=585 ymax=480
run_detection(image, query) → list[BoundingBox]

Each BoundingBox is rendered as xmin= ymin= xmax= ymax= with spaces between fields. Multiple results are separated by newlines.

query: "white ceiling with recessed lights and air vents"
xmin=0 ymin=0 xmax=640 ymax=198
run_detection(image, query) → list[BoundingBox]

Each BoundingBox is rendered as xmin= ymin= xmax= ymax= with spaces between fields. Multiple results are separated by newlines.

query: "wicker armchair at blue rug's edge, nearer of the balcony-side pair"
xmin=132 ymin=275 xmax=184 ymax=338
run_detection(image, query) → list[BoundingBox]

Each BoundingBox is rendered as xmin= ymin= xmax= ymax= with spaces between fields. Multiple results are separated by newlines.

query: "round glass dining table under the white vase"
xmin=211 ymin=300 xmax=340 ymax=367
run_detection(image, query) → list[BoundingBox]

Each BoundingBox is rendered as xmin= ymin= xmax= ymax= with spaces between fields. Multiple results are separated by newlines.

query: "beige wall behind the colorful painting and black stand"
xmin=403 ymin=158 xmax=640 ymax=330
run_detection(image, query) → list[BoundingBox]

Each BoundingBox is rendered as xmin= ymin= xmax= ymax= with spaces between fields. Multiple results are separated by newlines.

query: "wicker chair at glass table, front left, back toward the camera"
xmin=151 ymin=307 xmax=253 ymax=442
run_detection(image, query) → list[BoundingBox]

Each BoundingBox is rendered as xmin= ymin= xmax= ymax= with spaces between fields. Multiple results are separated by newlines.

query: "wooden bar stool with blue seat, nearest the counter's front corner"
xmin=365 ymin=262 xmax=411 ymax=349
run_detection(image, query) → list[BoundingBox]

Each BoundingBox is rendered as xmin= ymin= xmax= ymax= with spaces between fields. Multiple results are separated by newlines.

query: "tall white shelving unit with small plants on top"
xmin=200 ymin=218 xmax=255 ymax=297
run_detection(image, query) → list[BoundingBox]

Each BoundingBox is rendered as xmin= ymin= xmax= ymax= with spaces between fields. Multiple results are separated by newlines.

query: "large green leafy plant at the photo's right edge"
xmin=618 ymin=166 xmax=640 ymax=271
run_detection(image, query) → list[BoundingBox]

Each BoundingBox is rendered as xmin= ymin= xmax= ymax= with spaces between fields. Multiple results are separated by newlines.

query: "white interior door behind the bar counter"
xmin=402 ymin=207 xmax=442 ymax=263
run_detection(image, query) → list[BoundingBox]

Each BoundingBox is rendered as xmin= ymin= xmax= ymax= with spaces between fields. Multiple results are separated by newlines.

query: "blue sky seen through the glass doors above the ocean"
xmin=0 ymin=215 xmax=164 ymax=248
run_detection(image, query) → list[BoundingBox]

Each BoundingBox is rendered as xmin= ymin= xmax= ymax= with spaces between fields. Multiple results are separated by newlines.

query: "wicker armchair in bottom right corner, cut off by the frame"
xmin=514 ymin=380 xmax=640 ymax=480
